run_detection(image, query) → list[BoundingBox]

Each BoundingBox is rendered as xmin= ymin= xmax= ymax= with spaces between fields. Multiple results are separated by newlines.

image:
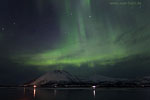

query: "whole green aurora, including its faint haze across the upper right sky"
xmin=12 ymin=0 xmax=150 ymax=67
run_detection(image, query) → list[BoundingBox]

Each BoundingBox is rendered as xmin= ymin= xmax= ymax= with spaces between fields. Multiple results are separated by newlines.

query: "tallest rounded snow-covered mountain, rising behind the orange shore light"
xmin=28 ymin=70 xmax=79 ymax=85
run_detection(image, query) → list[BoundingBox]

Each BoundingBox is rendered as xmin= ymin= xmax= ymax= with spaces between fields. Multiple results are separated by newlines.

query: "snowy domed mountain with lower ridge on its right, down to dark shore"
xmin=25 ymin=70 xmax=134 ymax=87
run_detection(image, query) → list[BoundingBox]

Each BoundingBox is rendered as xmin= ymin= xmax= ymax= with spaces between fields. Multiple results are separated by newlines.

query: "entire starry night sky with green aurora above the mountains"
xmin=0 ymin=0 xmax=150 ymax=84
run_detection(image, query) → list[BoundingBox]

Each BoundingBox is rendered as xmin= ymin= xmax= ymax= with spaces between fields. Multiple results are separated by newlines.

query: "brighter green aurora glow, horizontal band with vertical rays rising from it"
xmin=12 ymin=0 xmax=150 ymax=67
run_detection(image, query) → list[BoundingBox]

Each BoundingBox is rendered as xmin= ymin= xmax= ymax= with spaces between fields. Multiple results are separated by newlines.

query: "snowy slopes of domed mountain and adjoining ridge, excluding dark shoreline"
xmin=28 ymin=70 xmax=127 ymax=85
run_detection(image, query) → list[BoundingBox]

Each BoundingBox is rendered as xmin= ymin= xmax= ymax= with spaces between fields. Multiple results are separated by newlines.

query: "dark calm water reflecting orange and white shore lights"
xmin=0 ymin=88 xmax=150 ymax=100
